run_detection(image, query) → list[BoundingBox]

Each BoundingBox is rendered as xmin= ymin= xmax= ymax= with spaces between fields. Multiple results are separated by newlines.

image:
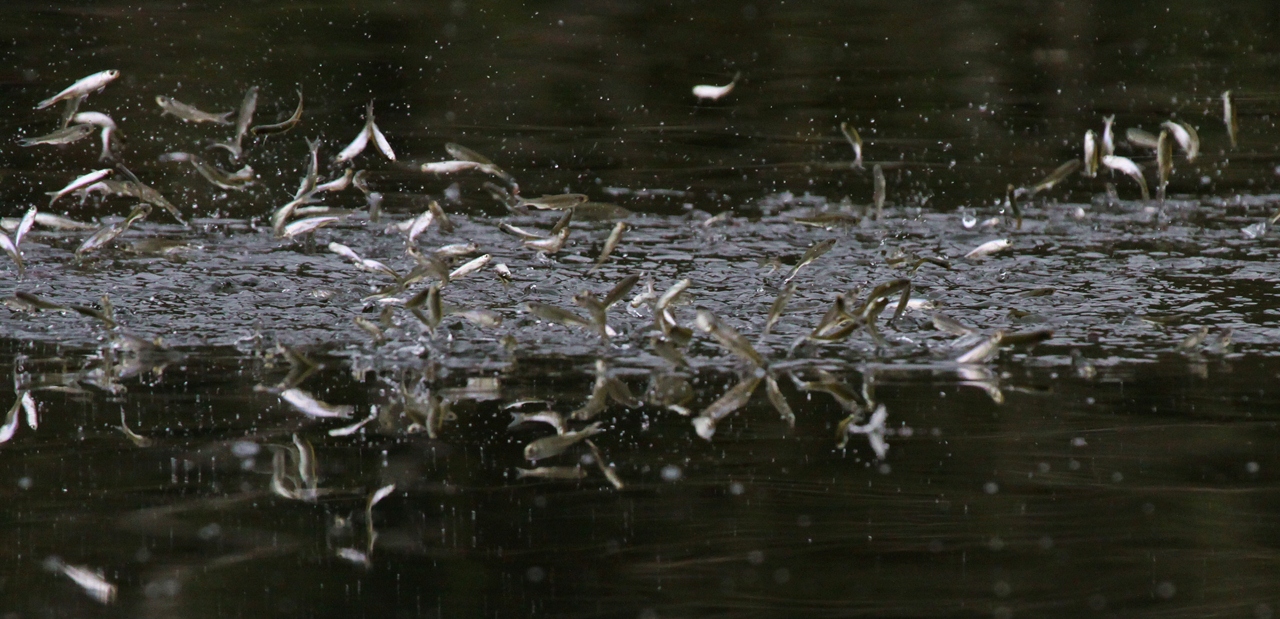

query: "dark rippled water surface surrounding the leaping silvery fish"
xmin=0 ymin=1 xmax=1280 ymax=618
